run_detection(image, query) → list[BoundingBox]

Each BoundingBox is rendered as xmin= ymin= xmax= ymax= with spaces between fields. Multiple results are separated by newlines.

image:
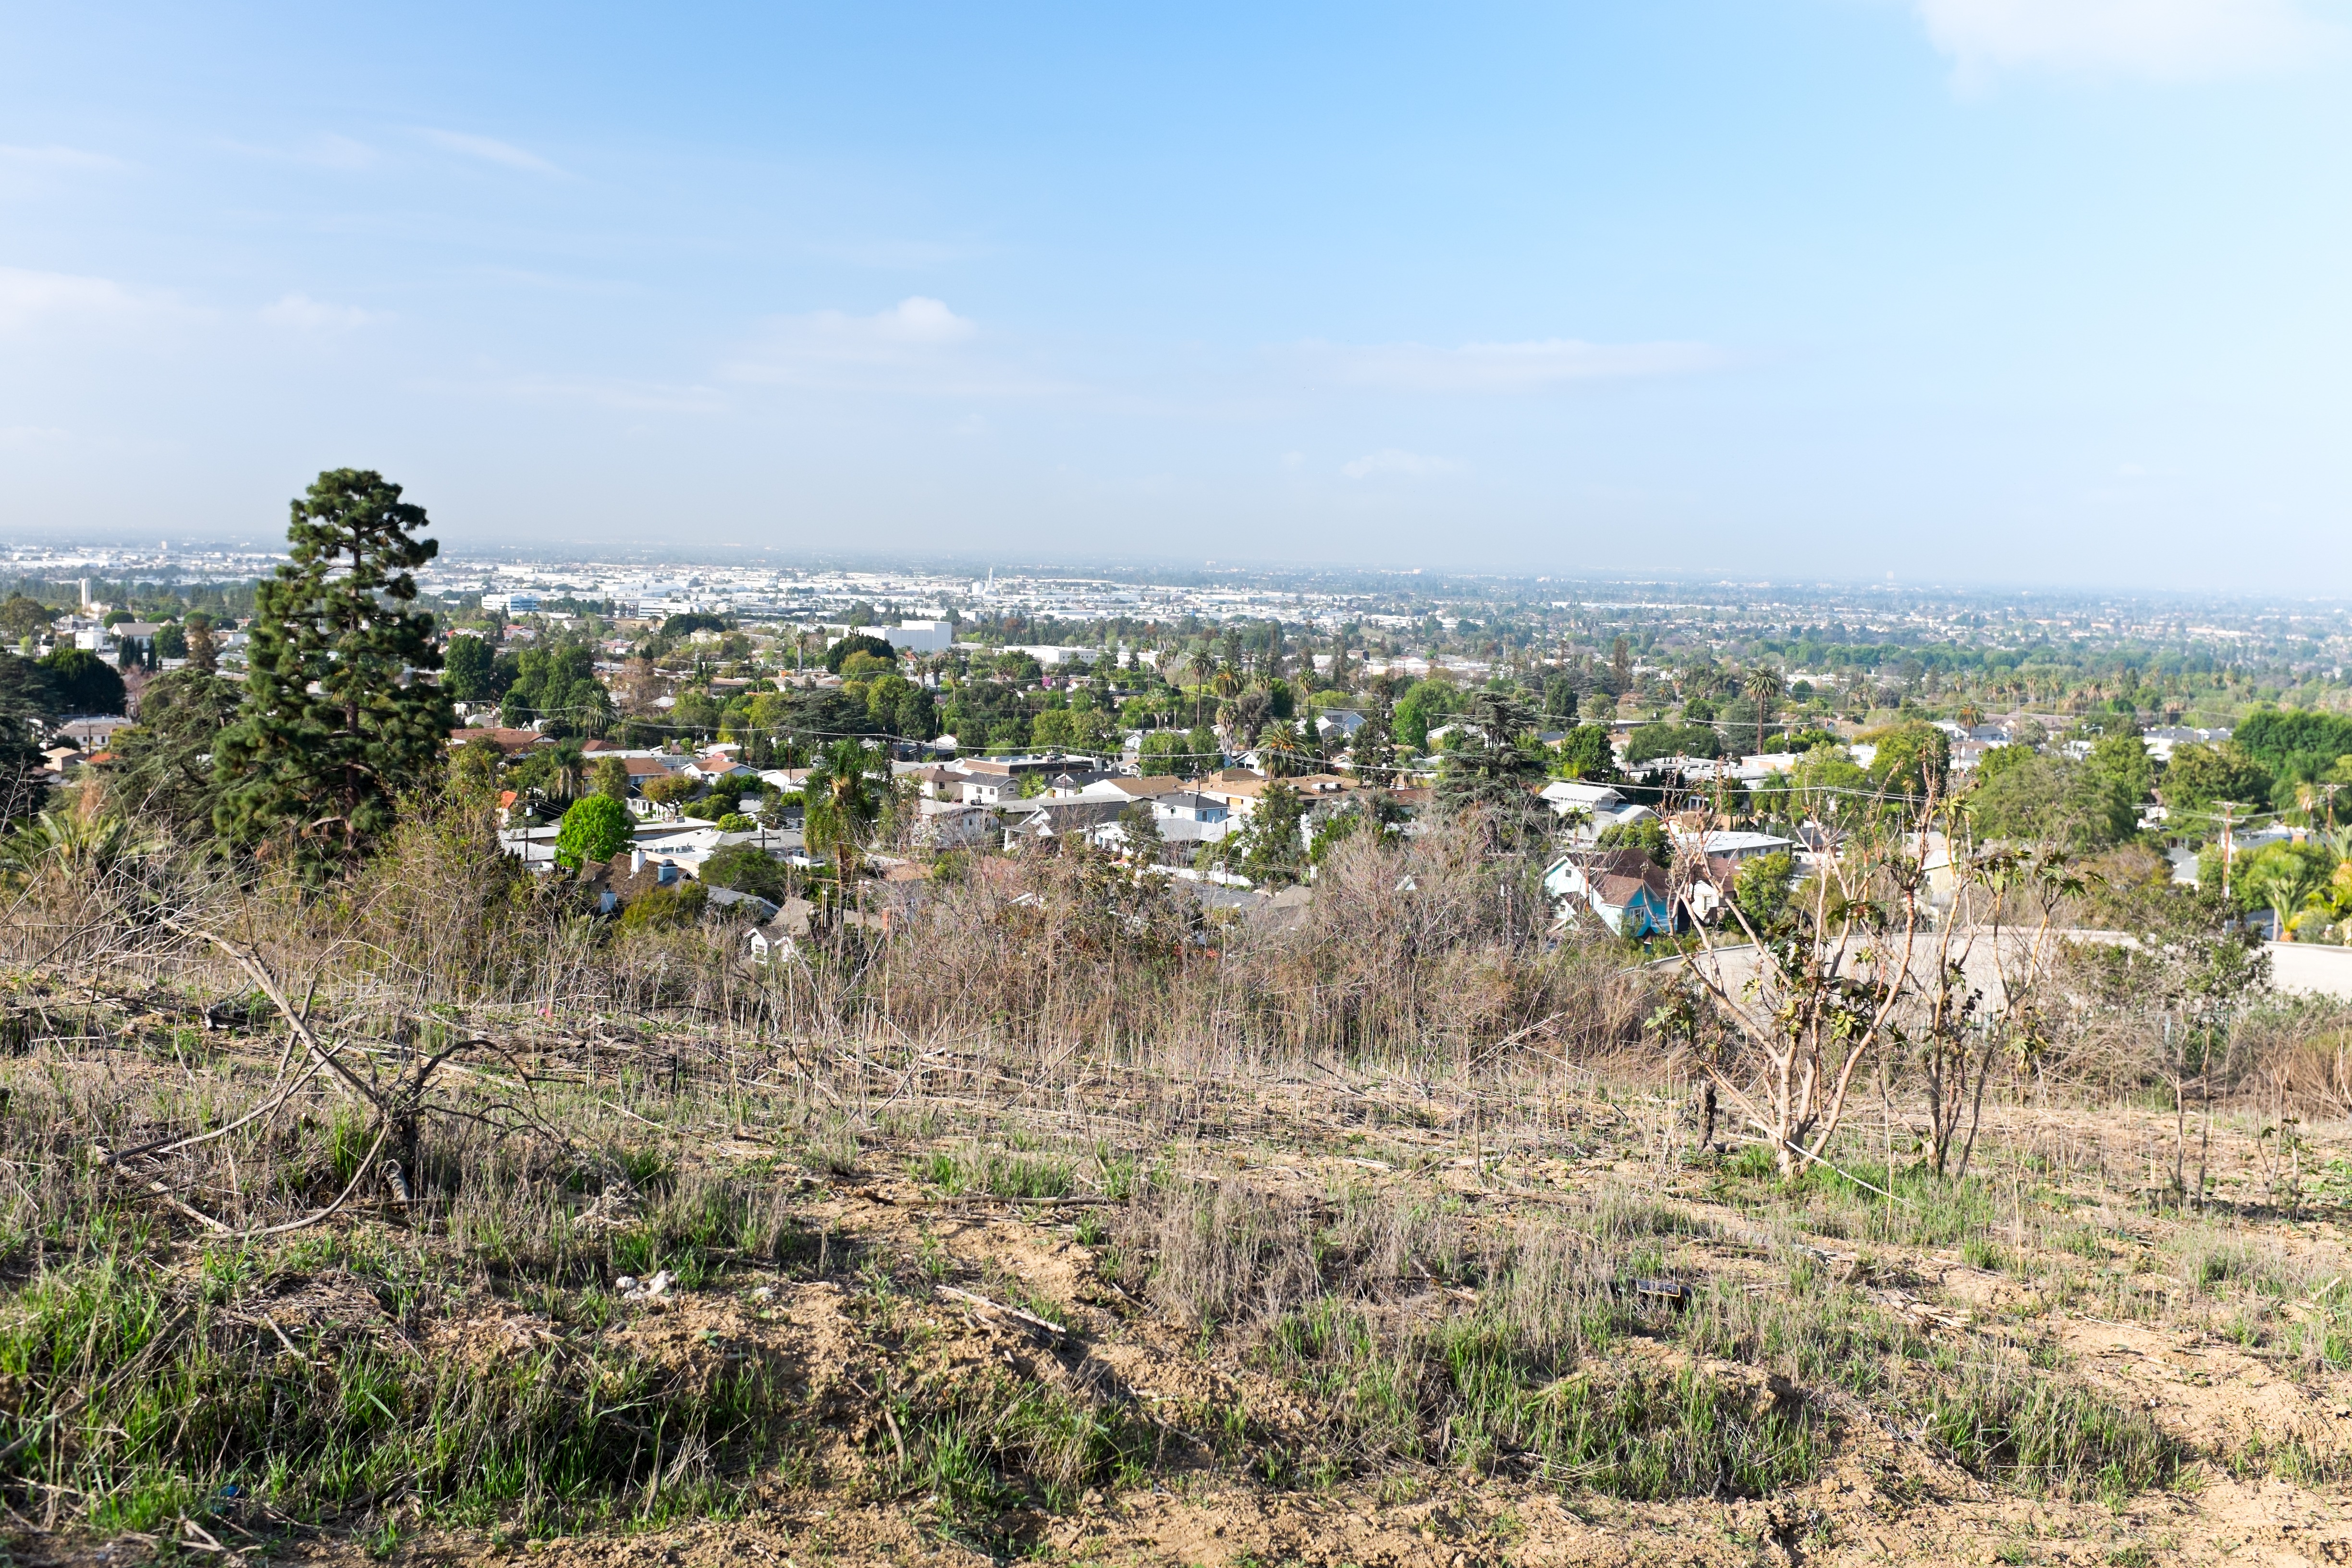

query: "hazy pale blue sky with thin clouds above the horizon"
xmin=0 ymin=0 xmax=2352 ymax=595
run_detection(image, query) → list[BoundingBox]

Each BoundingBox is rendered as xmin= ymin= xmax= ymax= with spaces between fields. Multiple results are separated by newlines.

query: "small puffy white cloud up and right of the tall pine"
xmin=722 ymin=294 xmax=1068 ymax=397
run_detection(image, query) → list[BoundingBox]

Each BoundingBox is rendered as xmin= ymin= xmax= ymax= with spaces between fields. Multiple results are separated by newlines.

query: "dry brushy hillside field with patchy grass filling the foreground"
xmin=0 ymin=821 xmax=2352 ymax=1568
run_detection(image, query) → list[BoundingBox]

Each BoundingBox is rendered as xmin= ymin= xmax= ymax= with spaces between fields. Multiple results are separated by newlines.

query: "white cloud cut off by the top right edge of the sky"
xmin=1914 ymin=0 xmax=2342 ymax=87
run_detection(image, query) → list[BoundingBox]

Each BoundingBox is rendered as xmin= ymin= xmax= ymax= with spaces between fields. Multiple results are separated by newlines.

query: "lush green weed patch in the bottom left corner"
xmin=0 ymin=1258 xmax=818 ymax=1531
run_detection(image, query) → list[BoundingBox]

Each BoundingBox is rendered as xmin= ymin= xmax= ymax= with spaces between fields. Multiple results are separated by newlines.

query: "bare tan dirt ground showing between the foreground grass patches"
xmin=12 ymin=1025 xmax=2352 ymax=1568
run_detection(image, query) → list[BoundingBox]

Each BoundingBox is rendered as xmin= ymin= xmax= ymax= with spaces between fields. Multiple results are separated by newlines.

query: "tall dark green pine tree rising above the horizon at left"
xmin=214 ymin=468 xmax=452 ymax=879
